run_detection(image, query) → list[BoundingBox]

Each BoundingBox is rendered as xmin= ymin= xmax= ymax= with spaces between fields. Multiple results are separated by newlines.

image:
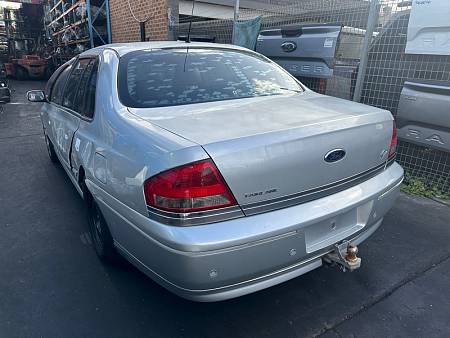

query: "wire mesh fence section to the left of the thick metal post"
xmin=175 ymin=0 xmax=370 ymax=99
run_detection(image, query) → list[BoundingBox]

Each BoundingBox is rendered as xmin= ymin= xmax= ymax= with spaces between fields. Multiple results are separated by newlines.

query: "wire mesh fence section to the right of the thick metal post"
xmin=361 ymin=0 xmax=450 ymax=192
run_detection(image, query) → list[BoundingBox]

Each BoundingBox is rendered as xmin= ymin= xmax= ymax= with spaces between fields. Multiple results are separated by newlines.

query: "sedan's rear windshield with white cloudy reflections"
xmin=118 ymin=48 xmax=303 ymax=108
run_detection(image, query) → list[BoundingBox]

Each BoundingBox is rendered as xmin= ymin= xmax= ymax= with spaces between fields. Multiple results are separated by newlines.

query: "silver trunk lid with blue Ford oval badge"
xmin=130 ymin=91 xmax=392 ymax=209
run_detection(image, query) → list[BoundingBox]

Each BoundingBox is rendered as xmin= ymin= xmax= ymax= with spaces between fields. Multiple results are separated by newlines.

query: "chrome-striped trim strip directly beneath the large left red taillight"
xmin=147 ymin=205 xmax=244 ymax=226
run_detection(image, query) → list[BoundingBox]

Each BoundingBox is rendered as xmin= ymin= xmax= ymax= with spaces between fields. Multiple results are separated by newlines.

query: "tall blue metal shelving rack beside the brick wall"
xmin=44 ymin=0 xmax=111 ymax=65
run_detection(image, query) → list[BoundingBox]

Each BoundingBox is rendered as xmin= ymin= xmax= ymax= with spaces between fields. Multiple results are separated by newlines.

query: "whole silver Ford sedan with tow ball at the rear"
xmin=28 ymin=41 xmax=403 ymax=301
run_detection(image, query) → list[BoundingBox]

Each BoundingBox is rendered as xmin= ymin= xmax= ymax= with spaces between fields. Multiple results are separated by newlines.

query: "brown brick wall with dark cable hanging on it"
xmin=109 ymin=0 xmax=169 ymax=42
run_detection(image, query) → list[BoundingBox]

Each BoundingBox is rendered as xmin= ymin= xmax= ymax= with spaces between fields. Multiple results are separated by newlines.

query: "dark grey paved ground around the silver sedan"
xmin=0 ymin=82 xmax=450 ymax=338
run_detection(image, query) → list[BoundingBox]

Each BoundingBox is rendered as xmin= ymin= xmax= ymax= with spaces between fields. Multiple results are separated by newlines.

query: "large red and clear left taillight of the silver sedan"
xmin=144 ymin=160 xmax=237 ymax=213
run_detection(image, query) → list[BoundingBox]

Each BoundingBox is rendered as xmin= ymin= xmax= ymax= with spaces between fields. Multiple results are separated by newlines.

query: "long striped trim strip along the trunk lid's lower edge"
xmin=241 ymin=159 xmax=394 ymax=216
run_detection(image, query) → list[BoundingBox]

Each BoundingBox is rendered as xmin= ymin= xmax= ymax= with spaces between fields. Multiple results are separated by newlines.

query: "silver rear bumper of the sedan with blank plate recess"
xmin=88 ymin=163 xmax=403 ymax=301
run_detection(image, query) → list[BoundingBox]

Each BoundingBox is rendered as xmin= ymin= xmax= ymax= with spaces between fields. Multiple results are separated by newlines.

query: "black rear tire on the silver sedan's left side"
xmin=88 ymin=197 xmax=117 ymax=264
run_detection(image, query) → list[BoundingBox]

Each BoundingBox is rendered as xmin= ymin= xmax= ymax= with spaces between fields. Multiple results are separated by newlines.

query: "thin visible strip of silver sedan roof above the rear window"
xmin=80 ymin=41 xmax=248 ymax=57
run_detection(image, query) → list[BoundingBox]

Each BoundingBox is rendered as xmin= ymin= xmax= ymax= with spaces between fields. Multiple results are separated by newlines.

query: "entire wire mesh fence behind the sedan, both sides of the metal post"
xmin=175 ymin=0 xmax=450 ymax=192
